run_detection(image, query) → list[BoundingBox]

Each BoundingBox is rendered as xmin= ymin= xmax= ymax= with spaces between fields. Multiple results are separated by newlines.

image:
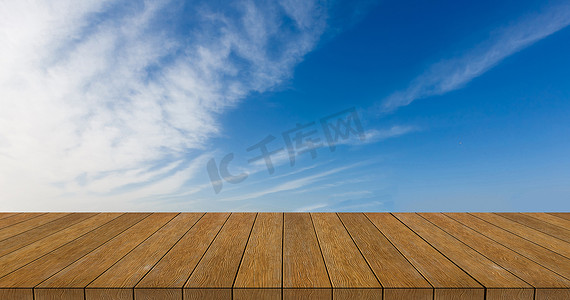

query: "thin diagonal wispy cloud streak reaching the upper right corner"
xmin=380 ymin=2 xmax=570 ymax=112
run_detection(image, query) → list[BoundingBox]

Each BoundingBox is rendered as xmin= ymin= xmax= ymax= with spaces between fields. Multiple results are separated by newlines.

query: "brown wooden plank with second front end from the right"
xmin=393 ymin=213 xmax=534 ymax=300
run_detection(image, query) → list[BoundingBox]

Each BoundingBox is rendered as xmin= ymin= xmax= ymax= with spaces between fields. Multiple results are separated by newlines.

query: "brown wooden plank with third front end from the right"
xmin=366 ymin=213 xmax=485 ymax=299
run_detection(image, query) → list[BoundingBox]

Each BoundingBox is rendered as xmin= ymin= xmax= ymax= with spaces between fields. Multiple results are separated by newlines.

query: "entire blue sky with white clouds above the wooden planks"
xmin=0 ymin=0 xmax=570 ymax=211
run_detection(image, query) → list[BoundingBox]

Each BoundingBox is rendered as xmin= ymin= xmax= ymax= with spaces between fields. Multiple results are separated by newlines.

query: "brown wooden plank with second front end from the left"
xmin=34 ymin=213 xmax=178 ymax=300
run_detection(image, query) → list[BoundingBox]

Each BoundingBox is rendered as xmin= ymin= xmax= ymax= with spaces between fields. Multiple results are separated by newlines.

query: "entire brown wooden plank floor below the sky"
xmin=0 ymin=213 xmax=570 ymax=300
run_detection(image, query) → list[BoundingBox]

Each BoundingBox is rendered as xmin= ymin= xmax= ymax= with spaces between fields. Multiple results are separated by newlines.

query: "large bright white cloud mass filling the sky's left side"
xmin=0 ymin=0 xmax=327 ymax=210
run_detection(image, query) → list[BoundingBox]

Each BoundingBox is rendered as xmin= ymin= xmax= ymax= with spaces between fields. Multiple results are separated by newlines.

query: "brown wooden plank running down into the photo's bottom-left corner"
xmin=0 ymin=213 xmax=149 ymax=300
